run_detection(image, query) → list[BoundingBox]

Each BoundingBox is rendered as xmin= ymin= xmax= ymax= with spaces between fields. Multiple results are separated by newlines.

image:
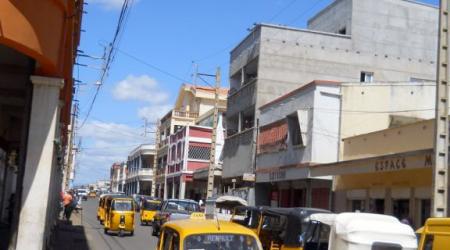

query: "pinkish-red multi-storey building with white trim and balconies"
xmin=165 ymin=126 xmax=214 ymax=200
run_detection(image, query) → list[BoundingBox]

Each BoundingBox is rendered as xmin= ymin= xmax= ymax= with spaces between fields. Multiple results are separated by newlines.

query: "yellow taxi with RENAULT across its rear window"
xmin=156 ymin=219 xmax=263 ymax=250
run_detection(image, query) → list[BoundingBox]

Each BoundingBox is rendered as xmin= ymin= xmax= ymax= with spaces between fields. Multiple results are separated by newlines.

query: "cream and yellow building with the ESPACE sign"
xmin=310 ymin=82 xmax=448 ymax=227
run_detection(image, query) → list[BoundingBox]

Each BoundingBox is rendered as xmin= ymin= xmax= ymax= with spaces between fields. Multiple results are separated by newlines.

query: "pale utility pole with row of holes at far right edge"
xmin=431 ymin=0 xmax=450 ymax=217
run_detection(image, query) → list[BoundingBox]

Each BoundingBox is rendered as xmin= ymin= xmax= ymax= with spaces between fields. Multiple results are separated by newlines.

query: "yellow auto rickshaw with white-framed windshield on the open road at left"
xmin=103 ymin=198 xmax=135 ymax=236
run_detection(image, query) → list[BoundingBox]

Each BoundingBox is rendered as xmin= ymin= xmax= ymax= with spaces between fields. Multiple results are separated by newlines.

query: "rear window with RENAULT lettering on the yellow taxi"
xmin=184 ymin=234 xmax=259 ymax=250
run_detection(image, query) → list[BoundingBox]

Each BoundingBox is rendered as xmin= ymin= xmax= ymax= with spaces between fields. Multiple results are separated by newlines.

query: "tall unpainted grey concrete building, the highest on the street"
xmin=223 ymin=0 xmax=438 ymax=202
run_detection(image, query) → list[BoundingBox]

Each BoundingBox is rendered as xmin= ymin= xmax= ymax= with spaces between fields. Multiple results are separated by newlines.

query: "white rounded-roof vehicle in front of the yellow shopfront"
xmin=300 ymin=213 xmax=417 ymax=250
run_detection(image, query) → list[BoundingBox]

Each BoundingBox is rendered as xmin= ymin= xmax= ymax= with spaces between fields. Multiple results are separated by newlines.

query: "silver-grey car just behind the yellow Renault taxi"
xmin=152 ymin=199 xmax=200 ymax=236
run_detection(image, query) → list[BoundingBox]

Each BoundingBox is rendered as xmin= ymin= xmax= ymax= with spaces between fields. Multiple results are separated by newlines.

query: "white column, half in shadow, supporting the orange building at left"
xmin=16 ymin=76 xmax=64 ymax=250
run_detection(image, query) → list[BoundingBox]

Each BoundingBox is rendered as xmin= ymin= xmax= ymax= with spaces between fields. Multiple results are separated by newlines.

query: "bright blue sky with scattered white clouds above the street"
xmin=74 ymin=0 xmax=438 ymax=184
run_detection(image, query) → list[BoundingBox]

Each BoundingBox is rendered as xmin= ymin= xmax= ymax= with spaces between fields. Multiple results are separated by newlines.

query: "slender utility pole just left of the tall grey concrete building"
xmin=206 ymin=68 xmax=220 ymax=198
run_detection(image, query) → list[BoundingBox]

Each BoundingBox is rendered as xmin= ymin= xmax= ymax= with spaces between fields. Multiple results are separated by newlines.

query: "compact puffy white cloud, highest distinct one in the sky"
xmin=112 ymin=75 xmax=169 ymax=103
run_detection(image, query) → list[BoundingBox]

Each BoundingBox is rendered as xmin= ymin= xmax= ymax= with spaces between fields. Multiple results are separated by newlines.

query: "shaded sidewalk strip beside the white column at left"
xmin=50 ymin=211 xmax=89 ymax=250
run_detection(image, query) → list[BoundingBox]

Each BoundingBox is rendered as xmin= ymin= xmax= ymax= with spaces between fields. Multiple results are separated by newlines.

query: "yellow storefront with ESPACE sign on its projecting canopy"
xmin=311 ymin=149 xmax=433 ymax=228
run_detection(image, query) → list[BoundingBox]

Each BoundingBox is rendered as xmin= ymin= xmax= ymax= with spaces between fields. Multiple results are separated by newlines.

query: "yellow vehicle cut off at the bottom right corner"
xmin=416 ymin=218 xmax=450 ymax=250
